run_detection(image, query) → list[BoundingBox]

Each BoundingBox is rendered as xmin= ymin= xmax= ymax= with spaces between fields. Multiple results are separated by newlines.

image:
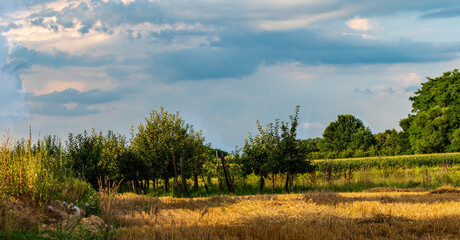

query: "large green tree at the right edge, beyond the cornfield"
xmin=402 ymin=69 xmax=460 ymax=153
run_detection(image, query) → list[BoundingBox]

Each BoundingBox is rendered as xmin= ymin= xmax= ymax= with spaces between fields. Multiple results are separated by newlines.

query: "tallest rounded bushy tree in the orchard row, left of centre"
xmin=131 ymin=107 xmax=207 ymax=194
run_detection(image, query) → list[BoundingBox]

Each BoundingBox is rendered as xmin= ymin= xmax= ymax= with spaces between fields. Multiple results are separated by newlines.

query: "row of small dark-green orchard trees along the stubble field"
xmin=4 ymin=106 xmax=313 ymax=196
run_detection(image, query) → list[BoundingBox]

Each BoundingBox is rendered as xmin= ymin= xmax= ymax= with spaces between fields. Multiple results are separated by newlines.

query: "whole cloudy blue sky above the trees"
xmin=0 ymin=0 xmax=460 ymax=150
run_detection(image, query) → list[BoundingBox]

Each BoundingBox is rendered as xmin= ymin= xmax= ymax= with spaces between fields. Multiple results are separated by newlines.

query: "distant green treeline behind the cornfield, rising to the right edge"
xmin=301 ymin=69 xmax=460 ymax=159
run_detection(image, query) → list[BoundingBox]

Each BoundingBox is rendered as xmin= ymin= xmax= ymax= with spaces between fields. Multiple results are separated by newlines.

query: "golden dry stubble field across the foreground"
xmin=111 ymin=188 xmax=460 ymax=239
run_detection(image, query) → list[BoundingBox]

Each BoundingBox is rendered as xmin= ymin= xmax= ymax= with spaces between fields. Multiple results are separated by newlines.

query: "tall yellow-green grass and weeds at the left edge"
xmin=0 ymin=136 xmax=99 ymax=235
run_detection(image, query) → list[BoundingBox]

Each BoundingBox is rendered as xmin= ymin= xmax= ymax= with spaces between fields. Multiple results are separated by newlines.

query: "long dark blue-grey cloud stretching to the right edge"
xmin=149 ymin=30 xmax=460 ymax=80
